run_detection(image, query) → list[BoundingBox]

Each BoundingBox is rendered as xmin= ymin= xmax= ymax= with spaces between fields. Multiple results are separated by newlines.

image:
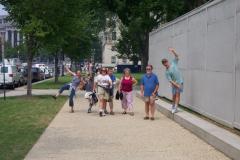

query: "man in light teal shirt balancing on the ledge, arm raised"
xmin=162 ymin=48 xmax=183 ymax=113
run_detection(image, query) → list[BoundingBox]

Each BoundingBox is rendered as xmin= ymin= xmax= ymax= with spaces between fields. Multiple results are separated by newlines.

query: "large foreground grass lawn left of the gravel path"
xmin=0 ymin=96 xmax=67 ymax=160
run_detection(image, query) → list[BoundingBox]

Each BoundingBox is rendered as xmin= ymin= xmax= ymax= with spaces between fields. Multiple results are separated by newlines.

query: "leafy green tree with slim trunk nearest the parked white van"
xmin=0 ymin=0 xmax=105 ymax=91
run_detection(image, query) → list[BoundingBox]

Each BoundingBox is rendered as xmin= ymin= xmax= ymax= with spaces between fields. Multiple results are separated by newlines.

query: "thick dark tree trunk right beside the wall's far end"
xmin=141 ymin=33 xmax=149 ymax=72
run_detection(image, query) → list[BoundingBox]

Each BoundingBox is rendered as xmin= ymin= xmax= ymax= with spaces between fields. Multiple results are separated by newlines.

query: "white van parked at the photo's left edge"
xmin=0 ymin=65 xmax=22 ymax=89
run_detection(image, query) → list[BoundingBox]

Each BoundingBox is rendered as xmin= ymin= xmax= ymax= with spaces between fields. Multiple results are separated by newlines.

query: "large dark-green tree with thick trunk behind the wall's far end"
xmin=102 ymin=0 xmax=184 ymax=69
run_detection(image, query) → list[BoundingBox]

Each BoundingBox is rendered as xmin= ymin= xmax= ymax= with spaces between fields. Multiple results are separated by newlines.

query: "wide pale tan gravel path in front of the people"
xmin=25 ymin=97 xmax=228 ymax=160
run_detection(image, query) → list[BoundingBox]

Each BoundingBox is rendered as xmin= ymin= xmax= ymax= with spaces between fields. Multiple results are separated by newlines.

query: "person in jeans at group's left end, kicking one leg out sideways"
xmin=53 ymin=67 xmax=83 ymax=113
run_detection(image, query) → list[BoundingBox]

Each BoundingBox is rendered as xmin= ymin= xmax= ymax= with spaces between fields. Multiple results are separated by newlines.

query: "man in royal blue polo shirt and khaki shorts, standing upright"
xmin=141 ymin=65 xmax=159 ymax=120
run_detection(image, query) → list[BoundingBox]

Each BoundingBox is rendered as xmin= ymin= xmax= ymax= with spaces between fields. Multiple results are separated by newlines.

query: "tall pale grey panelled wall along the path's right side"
xmin=149 ymin=0 xmax=240 ymax=128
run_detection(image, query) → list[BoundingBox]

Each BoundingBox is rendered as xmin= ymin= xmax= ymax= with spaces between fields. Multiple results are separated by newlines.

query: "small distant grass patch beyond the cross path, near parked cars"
xmin=32 ymin=76 xmax=72 ymax=89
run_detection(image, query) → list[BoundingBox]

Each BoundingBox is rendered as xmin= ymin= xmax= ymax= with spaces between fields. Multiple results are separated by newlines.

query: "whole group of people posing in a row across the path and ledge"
xmin=53 ymin=48 xmax=183 ymax=120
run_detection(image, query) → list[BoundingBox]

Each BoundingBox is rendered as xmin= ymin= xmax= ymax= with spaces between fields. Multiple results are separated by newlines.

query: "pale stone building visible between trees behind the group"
xmin=100 ymin=19 xmax=132 ymax=65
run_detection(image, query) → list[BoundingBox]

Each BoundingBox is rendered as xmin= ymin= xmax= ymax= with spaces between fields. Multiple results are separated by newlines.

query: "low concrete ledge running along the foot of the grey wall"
xmin=136 ymin=92 xmax=240 ymax=160
